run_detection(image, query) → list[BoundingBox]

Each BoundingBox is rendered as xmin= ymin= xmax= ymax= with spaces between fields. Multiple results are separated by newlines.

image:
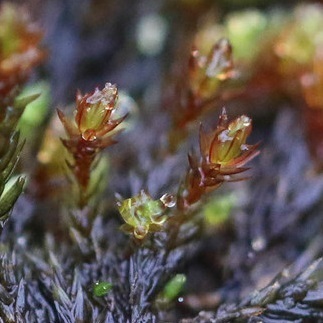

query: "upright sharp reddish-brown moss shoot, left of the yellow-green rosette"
xmin=57 ymin=83 xmax=125 ymax=207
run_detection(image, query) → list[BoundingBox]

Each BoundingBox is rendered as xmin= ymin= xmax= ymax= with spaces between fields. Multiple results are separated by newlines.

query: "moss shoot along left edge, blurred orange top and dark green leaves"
xmin=0 ymin=2 xmax=45 ymax=228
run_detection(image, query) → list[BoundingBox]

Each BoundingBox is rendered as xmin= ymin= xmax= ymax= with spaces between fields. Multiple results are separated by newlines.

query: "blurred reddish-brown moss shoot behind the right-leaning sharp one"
xmin=169 ymin=38 xmax=236 ymax=150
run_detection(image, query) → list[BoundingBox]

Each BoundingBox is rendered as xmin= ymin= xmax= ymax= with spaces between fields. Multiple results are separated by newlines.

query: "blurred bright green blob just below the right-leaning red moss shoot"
xmin=203 ymin=194 xmax=237 ymax=228
